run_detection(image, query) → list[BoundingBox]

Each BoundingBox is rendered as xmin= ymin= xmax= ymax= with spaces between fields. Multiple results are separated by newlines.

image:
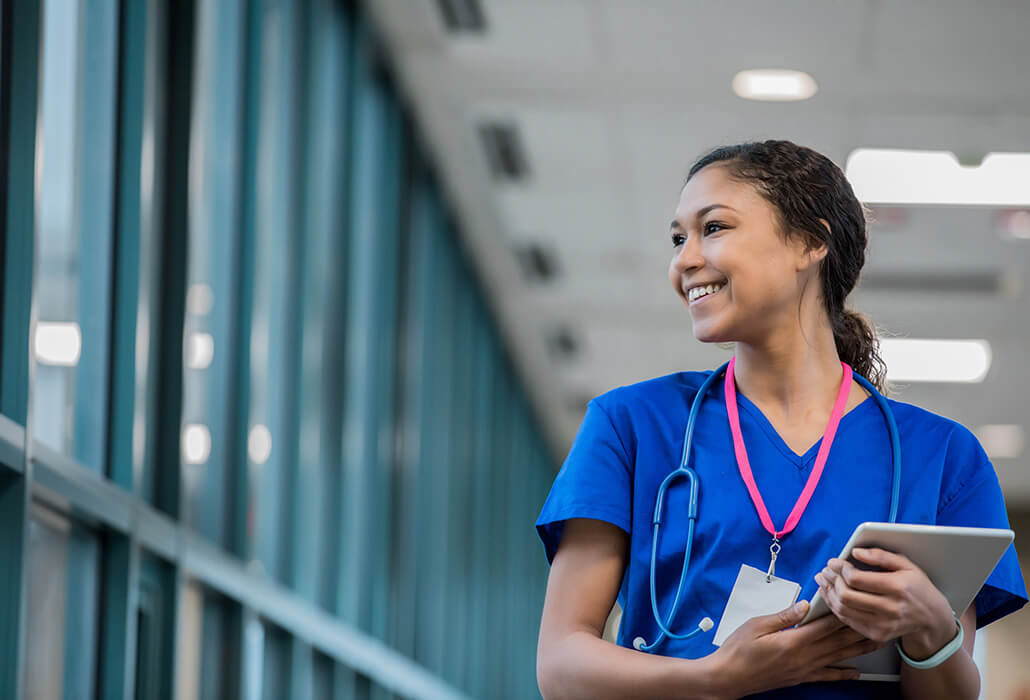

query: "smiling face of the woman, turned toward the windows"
xmin=668 ymin=164 xmax=822 ymax=343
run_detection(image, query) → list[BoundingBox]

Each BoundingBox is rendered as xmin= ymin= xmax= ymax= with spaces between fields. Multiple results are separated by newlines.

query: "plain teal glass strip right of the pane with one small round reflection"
xmin=290 ymin=2 xmax=349 ymax=609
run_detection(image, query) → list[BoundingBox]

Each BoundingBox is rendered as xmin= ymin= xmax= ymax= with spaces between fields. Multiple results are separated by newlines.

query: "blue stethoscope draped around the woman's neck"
xmin=633 ymin=362 xmax=901 ymax=654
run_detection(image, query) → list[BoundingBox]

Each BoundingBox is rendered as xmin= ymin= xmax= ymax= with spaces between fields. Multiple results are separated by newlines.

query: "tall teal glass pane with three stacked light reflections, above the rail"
xmin=181 ymin=0 xmax=245 ymax=548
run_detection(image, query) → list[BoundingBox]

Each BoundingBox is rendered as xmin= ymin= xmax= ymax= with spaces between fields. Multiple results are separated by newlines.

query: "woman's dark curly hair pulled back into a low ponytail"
xmin=686 ymin=140 xmax=887 ymax=392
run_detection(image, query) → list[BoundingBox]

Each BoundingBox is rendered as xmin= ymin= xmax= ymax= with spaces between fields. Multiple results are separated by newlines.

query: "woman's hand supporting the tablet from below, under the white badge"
xmin=709 ymin=600 xmax=883 ymax=698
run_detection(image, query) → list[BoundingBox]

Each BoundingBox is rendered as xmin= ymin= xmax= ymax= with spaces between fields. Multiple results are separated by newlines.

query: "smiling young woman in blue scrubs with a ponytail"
xmin=537 ymin=141 xmax=1027 ymax=700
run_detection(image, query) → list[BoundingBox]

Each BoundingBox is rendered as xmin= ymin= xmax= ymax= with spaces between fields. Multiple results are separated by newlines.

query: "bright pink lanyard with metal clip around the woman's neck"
xmin=725 ymin=357 xmax=852 ymax=579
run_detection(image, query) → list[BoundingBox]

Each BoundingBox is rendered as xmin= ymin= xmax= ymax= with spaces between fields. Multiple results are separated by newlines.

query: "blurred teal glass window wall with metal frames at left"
xmin=0 ymin=0 xmax=554 ymax=699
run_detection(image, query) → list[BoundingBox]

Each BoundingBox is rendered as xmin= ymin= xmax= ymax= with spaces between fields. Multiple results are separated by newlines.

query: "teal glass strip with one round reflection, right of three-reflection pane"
xmin=247 ymin=0 xmax=299 ymax=583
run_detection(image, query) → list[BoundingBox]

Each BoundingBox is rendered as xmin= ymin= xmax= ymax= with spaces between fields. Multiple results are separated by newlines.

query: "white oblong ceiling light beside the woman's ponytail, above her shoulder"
xmin=880 ymin=338 xmax=991 ymax=383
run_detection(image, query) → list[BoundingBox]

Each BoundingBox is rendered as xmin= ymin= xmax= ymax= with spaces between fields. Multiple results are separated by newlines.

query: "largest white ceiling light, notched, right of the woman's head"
xmin=845 ymin=148 xmax=1030 ymax=207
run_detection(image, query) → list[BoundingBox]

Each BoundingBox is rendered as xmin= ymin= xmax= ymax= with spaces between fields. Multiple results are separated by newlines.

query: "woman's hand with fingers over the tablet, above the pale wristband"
xmin=816 ymin=548 xmax=955 ymax=659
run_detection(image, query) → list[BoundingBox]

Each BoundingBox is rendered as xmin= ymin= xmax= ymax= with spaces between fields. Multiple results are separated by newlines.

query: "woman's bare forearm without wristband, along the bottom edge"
xmin=537 ymin=631 xmax=726 ymax=700
